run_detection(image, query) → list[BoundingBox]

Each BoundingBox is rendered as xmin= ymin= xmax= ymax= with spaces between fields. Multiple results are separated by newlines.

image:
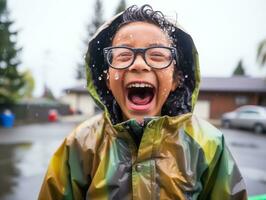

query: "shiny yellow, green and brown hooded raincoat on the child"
xmin=39 ymin=11 xmax=246 ymax=200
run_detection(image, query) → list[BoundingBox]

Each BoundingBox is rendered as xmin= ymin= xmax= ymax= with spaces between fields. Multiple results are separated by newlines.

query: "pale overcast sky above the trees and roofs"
xmin=8 ymin=0 xmax=266 ymax=96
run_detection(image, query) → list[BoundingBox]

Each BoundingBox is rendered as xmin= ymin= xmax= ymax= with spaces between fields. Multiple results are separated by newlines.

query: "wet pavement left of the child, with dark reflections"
xmin=0 ymin=119 xmax=77 ymax=200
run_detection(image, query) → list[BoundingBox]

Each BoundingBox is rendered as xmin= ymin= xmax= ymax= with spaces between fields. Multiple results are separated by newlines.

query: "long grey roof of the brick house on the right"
xmin=200 ymin=76 xmax=266 ymax=93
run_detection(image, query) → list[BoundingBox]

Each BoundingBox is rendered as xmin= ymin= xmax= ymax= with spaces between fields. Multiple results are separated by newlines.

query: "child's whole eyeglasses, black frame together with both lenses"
xmin=103 ymin=46 xmax=177 ymax=69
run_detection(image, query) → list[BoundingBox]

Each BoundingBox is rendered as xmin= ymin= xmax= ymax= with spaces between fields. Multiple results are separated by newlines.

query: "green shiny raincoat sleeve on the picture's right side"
xmin=200 ymin=138 xmax=247 ymax=200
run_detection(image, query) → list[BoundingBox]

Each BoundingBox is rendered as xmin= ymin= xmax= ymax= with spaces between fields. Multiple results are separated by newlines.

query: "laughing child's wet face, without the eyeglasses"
xmin=107 ymin=22 xmax=177 ymax=122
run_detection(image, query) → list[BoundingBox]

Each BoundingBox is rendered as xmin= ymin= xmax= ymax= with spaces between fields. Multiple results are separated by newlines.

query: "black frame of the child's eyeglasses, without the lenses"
xmin=103 ymin=46 xmax=177 ymax=70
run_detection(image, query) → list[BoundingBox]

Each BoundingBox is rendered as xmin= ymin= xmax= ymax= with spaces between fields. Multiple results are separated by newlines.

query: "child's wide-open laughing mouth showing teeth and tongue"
xmin=127 ymin=83 xmax=155 ymax=106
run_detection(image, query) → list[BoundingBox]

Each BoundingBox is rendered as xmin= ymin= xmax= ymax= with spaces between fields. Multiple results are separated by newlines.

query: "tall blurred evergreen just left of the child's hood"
xmin=76 ymin=0 xmax=104 ymax=80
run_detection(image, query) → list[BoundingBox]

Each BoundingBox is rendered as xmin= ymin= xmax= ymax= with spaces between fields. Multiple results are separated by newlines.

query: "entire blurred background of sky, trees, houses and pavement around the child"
xmin=0 ymin=0 xmax=266 ymax=200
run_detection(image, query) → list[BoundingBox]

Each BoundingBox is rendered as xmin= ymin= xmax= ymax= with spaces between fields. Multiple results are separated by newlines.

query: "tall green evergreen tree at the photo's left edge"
xmin=0 ymin=0 xmax=25 ymax=104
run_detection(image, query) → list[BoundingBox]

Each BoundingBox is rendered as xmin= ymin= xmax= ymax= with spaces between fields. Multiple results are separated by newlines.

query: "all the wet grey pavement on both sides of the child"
xmin=0 ymin=120 xmax=266 ymax=200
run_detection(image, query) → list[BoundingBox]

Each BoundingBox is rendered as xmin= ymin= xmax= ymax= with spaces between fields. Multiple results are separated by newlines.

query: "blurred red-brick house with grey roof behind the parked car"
xmin=195 ymin=76 xmax=266 ymax=119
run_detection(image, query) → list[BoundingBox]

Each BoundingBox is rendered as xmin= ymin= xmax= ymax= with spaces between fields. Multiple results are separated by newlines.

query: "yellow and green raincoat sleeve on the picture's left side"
xmin=38 ymin=123 xmax=93 ymax=200
